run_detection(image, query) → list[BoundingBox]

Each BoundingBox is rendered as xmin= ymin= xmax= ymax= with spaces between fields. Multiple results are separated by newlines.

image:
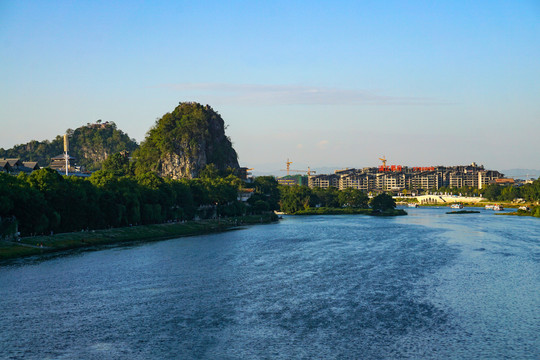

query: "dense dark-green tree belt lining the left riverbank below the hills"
xmin=0 ymin=167 xmax=277 ymax=236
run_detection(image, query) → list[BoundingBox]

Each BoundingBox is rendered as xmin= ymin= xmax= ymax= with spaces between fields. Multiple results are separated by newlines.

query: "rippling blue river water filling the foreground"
xmin=0 ymin=208 xmax=540 ymax=359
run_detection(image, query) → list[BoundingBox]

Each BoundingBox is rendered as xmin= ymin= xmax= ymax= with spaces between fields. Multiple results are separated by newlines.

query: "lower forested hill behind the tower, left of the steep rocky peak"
xmin=0 ymin=120 xmax=138 ymax=170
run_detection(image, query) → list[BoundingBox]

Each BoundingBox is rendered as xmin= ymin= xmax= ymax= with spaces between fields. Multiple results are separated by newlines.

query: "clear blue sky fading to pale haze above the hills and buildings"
xmin=0 ymin=0 xmax=540 ymax=170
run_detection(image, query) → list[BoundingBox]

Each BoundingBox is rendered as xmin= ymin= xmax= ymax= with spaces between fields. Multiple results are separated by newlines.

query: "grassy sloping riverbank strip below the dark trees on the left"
xmin=0 ymin=213 xmax=278 ymax=260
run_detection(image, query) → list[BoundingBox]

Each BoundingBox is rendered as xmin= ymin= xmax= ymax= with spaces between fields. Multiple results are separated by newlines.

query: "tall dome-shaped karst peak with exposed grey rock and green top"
xmin=136 ymin=103 xmax=239 ymax=179
